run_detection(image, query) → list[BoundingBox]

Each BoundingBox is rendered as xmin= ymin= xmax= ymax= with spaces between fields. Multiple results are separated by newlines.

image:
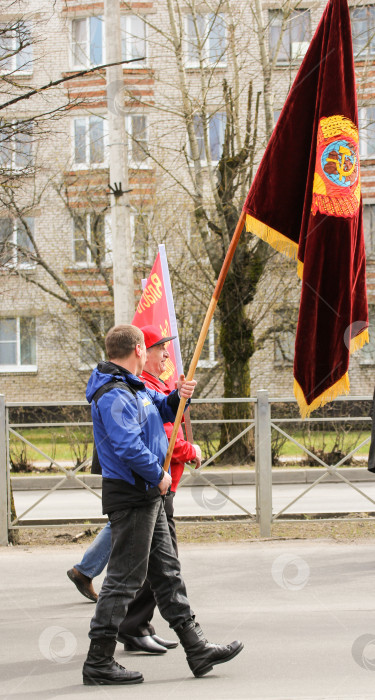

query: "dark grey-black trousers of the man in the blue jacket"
xmin=89 ymin=499 xmax=194 ymax=639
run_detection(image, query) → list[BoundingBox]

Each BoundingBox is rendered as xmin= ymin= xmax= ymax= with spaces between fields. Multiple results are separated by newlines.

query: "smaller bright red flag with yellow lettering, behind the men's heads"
xmin=132 ymin=246 xmax=179 ymax=390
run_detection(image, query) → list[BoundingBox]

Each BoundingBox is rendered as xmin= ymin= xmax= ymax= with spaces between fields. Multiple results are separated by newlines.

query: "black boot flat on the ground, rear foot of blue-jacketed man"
xmin=82 ymin=639 xmax=143 ymax=685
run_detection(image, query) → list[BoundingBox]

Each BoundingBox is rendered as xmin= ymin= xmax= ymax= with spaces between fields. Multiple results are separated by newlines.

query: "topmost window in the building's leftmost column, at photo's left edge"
xmin=0 ymin=21 xmax=33 ymax=73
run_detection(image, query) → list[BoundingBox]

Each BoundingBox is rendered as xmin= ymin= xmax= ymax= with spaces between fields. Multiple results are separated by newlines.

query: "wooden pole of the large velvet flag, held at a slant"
xmin=163 ymin=210 xmax=246 ymax=471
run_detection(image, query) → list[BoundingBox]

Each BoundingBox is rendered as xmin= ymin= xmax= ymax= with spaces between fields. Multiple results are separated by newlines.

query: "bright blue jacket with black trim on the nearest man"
xmin=86 ymin=362 xmax=179 ymax=512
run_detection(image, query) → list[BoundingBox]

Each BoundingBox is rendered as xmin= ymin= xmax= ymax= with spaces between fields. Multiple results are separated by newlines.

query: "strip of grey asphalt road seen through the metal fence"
xmin=10 ymin=480 xmax=375 ymax=524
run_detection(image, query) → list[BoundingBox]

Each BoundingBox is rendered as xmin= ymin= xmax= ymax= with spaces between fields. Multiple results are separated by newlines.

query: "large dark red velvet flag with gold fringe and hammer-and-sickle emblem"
xmin=244 ymin=0 xmax=368 ymax=417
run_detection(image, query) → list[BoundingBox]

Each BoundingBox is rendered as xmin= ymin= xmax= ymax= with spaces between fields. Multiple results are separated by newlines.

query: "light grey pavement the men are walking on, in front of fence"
xmin=0 ymin=540 xmax=375 ymax=700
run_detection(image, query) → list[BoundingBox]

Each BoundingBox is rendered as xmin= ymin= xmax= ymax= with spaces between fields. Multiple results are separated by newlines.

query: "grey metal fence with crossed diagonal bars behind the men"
xmin=0 ymin=390 xmax=375 ymax=545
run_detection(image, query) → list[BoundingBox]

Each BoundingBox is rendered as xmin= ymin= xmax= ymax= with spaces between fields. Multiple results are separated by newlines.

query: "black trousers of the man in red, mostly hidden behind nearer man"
xmin=119 ymin=491 xmax=178 ymax=637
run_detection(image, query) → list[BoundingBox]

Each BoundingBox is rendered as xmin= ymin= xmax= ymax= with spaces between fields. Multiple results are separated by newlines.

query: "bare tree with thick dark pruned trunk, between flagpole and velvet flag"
xmin=114 ymin=0 xmax=308 ymax=458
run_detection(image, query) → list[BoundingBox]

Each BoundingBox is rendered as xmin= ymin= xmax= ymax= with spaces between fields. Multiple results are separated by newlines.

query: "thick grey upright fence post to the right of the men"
xmin=255 ymin=389 xmax=272 ymax=537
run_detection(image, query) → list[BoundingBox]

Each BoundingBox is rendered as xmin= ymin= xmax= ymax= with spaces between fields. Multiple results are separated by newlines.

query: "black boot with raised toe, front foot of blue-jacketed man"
xmin=175 ymin=620 xmax=243 ymax=678
